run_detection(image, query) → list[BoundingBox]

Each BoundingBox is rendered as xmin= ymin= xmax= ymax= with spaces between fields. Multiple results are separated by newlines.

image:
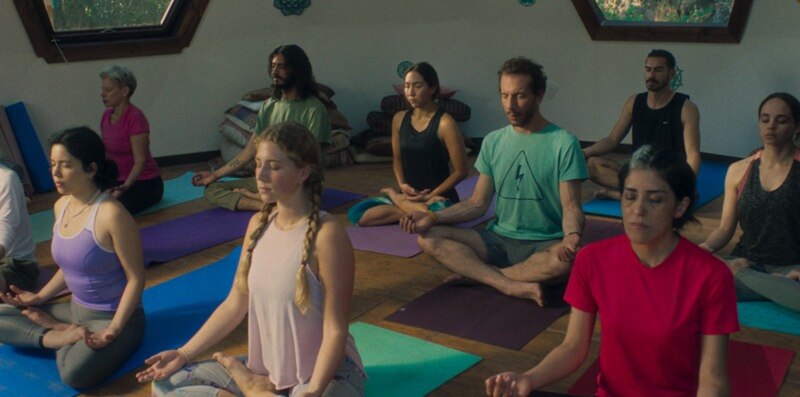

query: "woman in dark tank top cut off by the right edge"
xmin=700 ymin=92 xmax=800 ymax=311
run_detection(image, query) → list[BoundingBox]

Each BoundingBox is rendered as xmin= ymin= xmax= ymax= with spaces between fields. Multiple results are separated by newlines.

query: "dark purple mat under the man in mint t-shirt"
xmin=386 ymin=283 xmax=568 ymax=350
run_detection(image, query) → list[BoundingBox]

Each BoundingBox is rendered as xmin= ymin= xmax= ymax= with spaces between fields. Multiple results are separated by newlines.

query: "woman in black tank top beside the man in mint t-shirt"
xmin=347 ymin=62 xmax=467 ymax=226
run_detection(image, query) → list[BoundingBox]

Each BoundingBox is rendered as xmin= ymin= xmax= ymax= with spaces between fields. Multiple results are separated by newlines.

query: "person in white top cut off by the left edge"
xmin=0 ymin=161 xmax=39 ymax=293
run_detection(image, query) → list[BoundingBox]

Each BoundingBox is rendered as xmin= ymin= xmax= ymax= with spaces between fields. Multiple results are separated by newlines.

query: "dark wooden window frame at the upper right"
xmin=572 ymin=0 xmax=753 ymax=43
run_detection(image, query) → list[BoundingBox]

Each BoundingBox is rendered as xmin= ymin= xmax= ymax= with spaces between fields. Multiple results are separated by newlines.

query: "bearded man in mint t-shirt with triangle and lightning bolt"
xmin=401 ymin=57 xmax=588 ymax=305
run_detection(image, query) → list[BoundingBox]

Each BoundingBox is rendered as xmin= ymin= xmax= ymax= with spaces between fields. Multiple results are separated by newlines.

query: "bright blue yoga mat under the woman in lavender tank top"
xmin=0 ymin=248 xmax=241 ymax=397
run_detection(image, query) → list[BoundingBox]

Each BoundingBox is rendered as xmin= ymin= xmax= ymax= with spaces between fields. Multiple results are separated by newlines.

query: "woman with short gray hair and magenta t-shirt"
xmin=100 ymin=66 xmax=164 ymax=214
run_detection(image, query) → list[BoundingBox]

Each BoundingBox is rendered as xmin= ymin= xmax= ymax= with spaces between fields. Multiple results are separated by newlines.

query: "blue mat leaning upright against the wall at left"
xmin=6 ymin=102 xmax=56 ymax=192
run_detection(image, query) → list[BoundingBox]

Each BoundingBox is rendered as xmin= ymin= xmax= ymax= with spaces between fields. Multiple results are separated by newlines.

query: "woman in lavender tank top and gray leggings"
xmin=0 ymin=127 xmax=145 ymax=388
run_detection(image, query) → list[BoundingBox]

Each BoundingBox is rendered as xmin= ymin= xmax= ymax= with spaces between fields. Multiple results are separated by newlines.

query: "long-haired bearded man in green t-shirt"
xmin=192 ymin=44 xmax=331 ymax=211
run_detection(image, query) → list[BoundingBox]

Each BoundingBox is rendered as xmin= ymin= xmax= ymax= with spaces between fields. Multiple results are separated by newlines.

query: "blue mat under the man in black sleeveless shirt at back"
xmin=583 ymin=161 xmax=728 ymax=218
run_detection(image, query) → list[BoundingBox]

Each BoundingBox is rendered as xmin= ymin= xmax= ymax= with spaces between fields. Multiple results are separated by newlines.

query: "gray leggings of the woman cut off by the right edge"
xmin=726 ymin=257 xmax=800 ymax=311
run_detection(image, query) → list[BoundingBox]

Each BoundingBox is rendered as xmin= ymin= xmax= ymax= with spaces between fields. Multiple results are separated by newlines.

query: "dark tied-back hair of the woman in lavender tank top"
xmin=50 ymin=126 xmax=119 ymax=190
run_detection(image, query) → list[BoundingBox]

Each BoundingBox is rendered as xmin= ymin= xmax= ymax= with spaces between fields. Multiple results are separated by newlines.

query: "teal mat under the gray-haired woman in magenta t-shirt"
xmin=30 ymin=172 xmax=230 ymax=244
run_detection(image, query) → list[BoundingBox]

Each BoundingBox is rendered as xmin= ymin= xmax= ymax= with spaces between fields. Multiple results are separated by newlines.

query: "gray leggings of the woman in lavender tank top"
xmin=0 ymin=302 xmax=145 ymax=389
